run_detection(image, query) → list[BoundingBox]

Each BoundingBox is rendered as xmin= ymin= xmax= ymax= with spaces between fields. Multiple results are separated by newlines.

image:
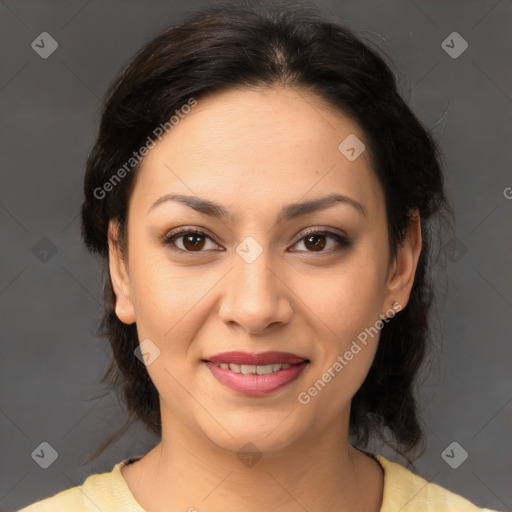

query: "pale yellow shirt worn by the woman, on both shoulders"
xmin=18 ymin=455 xmax=495 ymax=512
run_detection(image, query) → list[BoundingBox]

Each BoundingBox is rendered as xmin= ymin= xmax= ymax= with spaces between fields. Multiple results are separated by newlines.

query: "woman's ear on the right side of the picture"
xmin=384 ymin=209 xmax=422 ymax=310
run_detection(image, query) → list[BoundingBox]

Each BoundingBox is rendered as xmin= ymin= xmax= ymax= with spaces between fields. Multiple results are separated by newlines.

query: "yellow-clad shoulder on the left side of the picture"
xmin=18 ymin=460 xmax=142 ymax=512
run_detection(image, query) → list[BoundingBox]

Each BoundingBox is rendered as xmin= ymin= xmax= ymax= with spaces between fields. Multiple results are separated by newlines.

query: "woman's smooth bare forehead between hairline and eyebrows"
xmin=132 ymin=87 xmax=384 ymax=221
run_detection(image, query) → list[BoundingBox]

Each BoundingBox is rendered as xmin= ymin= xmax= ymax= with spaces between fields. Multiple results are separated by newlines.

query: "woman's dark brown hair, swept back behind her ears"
xmin=82 ymin=2 xmax=452 ymax=460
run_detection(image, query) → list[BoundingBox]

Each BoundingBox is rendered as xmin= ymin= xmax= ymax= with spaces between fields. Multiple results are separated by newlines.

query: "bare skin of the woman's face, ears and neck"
xmin=109 ymin=86 xmax=421 ymax=512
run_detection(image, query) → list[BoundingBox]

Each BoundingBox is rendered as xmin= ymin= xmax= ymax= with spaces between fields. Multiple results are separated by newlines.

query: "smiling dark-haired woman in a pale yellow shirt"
xmin=19 ymin=2 xmax=500 ymax=512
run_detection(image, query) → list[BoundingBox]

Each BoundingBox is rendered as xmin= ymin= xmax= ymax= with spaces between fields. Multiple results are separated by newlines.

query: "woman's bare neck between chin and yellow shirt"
xmin=123 ymin=408 xmax=383 ymax=512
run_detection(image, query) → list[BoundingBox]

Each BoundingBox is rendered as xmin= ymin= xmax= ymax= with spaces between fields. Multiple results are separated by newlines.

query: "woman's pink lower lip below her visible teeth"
xmin=205 ymin=361 xmax=308 ymax=396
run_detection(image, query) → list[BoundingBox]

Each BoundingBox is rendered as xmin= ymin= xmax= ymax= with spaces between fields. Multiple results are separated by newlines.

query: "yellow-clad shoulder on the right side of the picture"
xmin=375 ymin=455 xmax=500 ymax=512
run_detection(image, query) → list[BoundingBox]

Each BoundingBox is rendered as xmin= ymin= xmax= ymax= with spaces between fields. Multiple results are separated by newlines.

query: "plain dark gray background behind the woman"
xmin=0 ymin=0 xmax=512 ymax=510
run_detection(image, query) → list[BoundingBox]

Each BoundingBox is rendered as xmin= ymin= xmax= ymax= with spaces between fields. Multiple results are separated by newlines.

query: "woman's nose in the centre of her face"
xmin=219 ymin=251 xmax=293 ymax=335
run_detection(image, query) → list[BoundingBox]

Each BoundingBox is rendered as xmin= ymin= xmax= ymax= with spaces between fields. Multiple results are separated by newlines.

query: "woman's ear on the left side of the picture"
xmin=108 ymin=220 xmax=135 ymax=324
